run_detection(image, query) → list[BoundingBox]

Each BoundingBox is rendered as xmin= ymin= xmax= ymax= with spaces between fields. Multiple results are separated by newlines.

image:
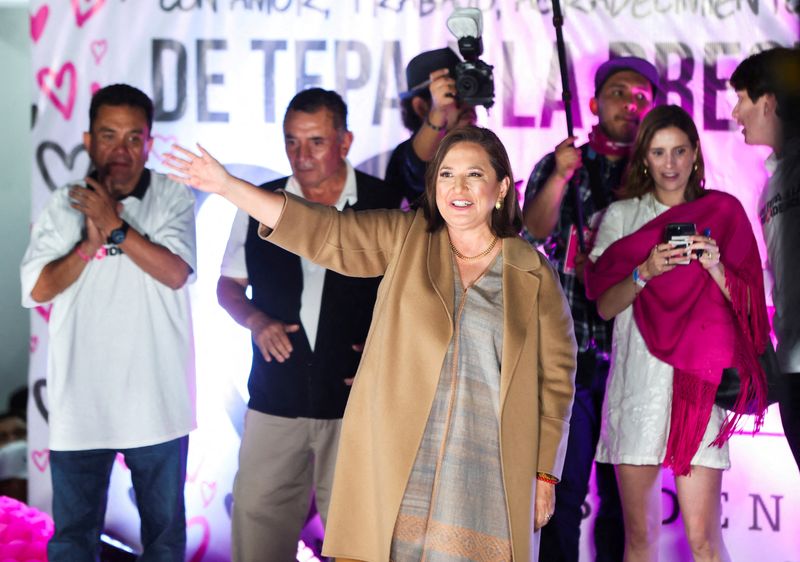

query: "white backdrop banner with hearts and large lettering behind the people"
xmin=29 ymin=0 xmax=800 ymax=562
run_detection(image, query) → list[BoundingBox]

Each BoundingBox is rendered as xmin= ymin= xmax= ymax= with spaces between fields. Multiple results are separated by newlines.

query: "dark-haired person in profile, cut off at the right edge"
xmin=730 ymin=47 xmax=800 ymax=468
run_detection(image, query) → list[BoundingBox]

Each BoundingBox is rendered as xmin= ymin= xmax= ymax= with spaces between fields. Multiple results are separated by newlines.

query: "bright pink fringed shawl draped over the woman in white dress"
xmin=586 ymin=190 xmax=769 ymax=475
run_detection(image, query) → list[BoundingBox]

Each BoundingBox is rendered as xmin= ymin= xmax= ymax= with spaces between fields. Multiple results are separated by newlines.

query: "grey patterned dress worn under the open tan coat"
xmin=391 ymin=253 xmax=511 ymax=562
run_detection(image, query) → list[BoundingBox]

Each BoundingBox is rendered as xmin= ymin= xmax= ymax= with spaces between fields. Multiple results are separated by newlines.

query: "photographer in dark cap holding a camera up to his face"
xmin=386 ymin=47 xmax=476 ymax=203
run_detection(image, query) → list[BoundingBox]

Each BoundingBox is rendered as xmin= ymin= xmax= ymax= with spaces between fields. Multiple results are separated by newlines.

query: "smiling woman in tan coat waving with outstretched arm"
xmin=169 ymin=127 xmax=575 ymax=562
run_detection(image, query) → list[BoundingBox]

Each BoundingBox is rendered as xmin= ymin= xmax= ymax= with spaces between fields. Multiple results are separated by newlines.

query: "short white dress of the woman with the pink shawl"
xmin=589 ymin=193 xmax=730 ymax=469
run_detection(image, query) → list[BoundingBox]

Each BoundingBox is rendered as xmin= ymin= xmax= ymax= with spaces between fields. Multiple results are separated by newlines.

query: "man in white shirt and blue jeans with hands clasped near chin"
xmin=21 ymin=84 xmax=197 ymax=562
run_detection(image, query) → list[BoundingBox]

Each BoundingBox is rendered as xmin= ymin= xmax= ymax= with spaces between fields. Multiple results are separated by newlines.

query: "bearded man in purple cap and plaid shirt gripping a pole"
xmin=523 ymin=57 xmax=658 ymax=562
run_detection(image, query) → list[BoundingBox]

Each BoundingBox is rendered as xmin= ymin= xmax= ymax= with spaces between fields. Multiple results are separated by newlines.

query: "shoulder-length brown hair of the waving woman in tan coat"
xmin=422 ymin=125 xmax=522 ymax=234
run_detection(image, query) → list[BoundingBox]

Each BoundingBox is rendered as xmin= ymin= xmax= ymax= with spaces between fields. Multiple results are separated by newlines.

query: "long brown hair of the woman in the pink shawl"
xmin=618 ymin=105 xmax=706 ymax=201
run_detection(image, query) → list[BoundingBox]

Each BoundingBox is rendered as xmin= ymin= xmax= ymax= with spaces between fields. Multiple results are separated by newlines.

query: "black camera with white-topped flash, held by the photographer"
xmin=447 ymin=8 xmax=494 ymax=108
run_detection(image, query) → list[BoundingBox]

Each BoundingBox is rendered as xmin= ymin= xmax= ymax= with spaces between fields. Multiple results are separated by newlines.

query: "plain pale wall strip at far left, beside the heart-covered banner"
xmin=0 ymin=2 xmax=31 ymax=411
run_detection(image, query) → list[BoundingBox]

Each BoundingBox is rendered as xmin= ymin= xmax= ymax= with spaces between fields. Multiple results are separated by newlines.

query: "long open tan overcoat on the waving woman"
xmin=261 ymin=195 xmax=576 ymax=562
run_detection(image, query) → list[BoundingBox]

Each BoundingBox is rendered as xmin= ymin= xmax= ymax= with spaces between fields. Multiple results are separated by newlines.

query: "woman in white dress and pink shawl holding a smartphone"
xmin=586 ymin=106 xmax=769 ymax=562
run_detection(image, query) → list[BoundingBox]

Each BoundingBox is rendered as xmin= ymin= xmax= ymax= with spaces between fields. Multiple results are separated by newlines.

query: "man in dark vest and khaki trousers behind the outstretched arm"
xmin=217 ymin=88 xmax=396 ymax=562
